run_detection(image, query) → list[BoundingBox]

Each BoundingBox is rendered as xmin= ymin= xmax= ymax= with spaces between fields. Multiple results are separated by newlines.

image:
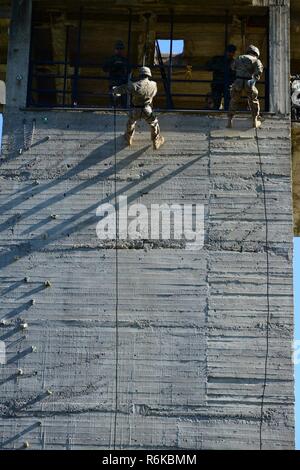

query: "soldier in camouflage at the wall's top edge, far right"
xmin=227 ymin=45 xmax=264 ymax=128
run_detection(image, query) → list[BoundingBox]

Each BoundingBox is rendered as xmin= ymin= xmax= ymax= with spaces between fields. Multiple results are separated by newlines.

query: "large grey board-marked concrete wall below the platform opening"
xmin=0 ymin=111 xmax=294 ymax=449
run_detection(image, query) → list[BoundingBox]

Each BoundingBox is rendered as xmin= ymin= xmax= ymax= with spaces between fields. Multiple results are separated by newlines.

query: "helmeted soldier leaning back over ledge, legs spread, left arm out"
xmin=113 ymin=67 xmax=165 ymax=150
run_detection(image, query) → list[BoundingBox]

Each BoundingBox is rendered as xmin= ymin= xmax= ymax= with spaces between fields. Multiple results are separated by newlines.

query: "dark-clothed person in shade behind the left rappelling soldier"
xmin=103 ymin=41 xmax=130 ymax=108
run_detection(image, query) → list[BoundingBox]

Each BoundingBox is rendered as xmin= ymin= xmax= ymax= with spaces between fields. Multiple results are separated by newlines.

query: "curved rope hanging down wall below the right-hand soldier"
xmin=255 ymin=129 xmax=271 ymax=450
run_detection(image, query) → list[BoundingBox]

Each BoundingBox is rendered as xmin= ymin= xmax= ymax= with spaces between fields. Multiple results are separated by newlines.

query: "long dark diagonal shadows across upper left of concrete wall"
xmin=0 ymin=129 xmax=207 ymax=272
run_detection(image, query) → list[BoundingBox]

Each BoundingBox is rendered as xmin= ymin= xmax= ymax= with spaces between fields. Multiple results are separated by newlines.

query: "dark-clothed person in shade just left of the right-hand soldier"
xmin=206 ymin=44 xmax=236 ymax=111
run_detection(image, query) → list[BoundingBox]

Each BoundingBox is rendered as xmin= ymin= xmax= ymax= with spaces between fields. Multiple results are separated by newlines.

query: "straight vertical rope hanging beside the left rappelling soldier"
xmin=113 ymin=98 xmax=119 ymax=450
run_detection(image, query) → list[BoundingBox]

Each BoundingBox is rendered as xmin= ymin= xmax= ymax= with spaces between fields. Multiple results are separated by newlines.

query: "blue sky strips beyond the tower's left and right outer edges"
xmin=0 ymin=110 xmax=300 ymax=450
